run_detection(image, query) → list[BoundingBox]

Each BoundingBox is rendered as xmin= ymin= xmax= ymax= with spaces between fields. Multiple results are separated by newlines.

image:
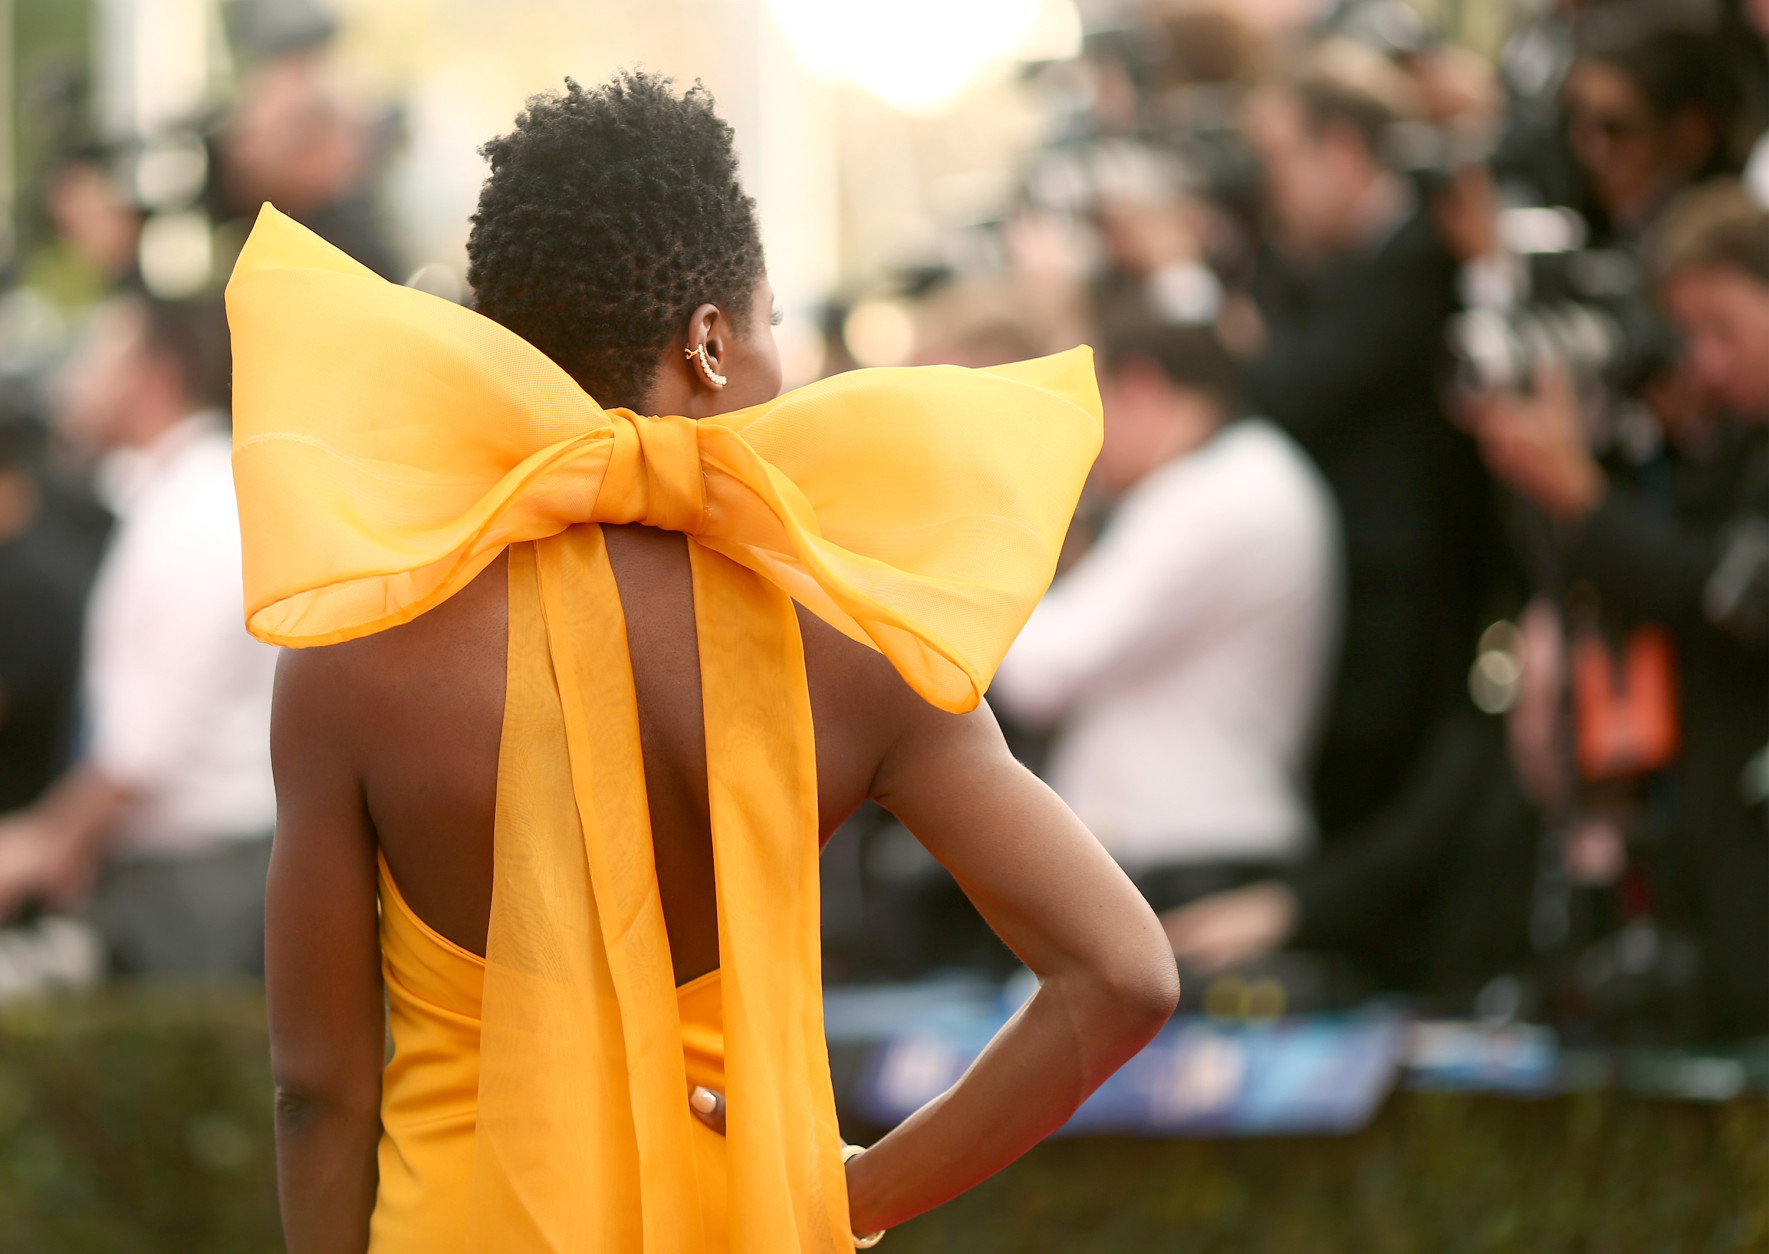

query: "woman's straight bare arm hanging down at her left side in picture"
xmin=265 ymin=649 xmax=386 ymax=1254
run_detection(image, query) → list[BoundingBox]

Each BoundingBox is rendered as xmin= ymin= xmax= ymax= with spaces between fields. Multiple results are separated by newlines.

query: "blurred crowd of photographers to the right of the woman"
xmin=826 ymin=0 xmax=1769 ymax=1044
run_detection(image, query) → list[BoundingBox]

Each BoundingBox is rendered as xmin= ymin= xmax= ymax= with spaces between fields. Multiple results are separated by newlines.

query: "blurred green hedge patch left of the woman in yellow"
xmin=0 ymin=987 xmax=283 ymax=1254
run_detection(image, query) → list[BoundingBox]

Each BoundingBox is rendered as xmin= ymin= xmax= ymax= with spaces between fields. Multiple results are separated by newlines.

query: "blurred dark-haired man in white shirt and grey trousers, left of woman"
xmin=0 ymin=295 xmax=276 ymax=975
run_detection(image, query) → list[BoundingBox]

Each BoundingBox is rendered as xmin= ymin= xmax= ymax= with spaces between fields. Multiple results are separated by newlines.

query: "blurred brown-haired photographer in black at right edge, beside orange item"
xmin=1468 ymin=182 xmax=1769 ymax=1036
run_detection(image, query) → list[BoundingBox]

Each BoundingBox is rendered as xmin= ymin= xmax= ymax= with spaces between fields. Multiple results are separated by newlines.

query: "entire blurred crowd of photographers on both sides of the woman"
xmin=0 ymin=0 xmax=1769 ymax=1044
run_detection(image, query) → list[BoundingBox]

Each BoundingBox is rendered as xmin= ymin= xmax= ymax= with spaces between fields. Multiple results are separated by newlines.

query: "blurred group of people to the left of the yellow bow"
xmin=0 ymin=0 xmax=403 ymax=994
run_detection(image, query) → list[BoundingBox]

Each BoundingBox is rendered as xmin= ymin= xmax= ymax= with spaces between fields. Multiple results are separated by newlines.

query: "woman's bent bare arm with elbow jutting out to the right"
xmin=847 ymin=693 xmax=1180 ymax=1233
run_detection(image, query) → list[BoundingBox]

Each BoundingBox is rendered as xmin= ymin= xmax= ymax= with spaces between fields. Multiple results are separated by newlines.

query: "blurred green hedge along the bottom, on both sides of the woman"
xmin=0 ymin=989 xmax=1769 ymax=1254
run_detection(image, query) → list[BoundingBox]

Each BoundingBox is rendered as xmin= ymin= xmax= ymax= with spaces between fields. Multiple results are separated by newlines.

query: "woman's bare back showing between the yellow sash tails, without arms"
xmin=284 ymin=525 xmax=920 ymax=983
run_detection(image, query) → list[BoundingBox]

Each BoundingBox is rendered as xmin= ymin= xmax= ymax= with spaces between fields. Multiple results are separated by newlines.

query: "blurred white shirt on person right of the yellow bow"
xmin=989 ymin=419 xmax=1339 ymax=870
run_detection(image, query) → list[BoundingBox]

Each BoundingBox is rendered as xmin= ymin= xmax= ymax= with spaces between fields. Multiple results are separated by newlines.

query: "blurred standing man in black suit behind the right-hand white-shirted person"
xmin=1247 ymin=39 xmax=1491 ymax=844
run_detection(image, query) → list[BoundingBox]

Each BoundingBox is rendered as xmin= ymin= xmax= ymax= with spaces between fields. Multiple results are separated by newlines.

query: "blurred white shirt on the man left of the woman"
xmin=85 ymin=412 xmax=276 ymax=854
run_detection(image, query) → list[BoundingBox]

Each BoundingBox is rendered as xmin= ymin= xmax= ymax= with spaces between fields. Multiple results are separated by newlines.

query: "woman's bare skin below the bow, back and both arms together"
xmin=265 ymin=527 xmax=1178 ymax=1254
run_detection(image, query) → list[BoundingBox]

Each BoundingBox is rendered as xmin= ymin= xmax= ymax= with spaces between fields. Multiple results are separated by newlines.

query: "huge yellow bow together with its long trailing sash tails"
xmin=228 ymin=207 xmax=1100 ymax=1254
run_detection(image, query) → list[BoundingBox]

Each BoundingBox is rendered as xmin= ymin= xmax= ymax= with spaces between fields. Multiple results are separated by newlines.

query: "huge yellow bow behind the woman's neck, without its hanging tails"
xmin=228 ymin=205 xmax=1100 ymax=711
